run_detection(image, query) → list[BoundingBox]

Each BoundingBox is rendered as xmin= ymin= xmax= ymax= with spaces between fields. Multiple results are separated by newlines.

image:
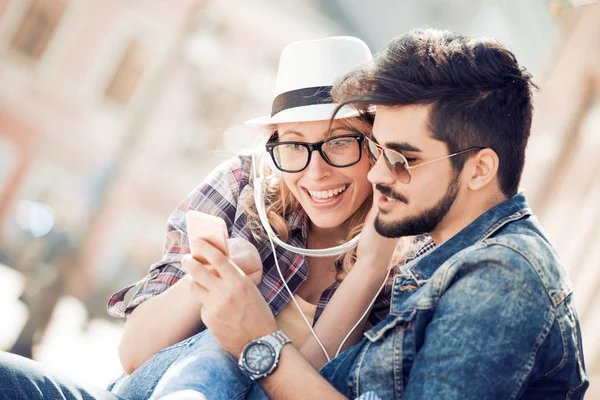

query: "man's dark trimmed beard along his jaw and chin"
xmin=375 ymin=176 xmax=460 ymax=238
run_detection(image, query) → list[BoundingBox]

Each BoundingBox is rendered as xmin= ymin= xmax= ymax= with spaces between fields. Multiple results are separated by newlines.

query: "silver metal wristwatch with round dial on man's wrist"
xmin=238 ymin=330 xmax=292 ymax=381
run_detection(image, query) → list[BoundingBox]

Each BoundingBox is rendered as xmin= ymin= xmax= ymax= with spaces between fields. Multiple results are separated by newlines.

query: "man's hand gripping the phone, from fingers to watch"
xmin=184 ymin=239 xmax=278 ymax=358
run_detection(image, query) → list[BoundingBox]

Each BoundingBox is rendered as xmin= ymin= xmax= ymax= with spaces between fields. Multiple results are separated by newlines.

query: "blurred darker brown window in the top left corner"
xmin=11 ymin=0 xmax=68 ymax=60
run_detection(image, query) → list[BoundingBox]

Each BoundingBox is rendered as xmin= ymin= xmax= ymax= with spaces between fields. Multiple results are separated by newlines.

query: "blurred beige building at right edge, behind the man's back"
xmin=523 ymin=4 xmax=600 ymax=392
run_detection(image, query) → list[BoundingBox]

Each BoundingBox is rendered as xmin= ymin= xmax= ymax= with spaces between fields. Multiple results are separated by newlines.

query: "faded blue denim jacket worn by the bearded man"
xmin=321 ymin=194 xmax=589 ymax=400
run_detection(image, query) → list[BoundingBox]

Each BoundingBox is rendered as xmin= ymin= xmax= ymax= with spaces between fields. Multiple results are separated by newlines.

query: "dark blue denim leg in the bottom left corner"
xmin=0 ymin=352 xmax=119 ymax=400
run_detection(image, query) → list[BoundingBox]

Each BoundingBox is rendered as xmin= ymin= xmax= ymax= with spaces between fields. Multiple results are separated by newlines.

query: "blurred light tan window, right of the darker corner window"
xmin=104 ymin=39 xmax=151 ymax=105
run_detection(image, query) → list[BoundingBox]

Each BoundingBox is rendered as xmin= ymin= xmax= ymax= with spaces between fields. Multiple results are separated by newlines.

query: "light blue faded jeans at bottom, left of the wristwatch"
xmin=109 ymin=330 xmax=267 ymax=400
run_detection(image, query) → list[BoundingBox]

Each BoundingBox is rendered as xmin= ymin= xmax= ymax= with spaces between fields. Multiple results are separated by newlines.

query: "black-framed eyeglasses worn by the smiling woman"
xmin=266 ymin=133 xmax=365 ymax=172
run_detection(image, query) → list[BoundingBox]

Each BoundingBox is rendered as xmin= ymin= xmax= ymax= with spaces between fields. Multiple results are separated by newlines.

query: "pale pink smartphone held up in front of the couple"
xmin=185 ymin=210 xmax=229 ymax=256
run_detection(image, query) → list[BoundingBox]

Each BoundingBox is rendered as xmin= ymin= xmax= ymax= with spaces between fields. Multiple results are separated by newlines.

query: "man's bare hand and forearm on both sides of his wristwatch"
xmin=184 ymin=240 xmax=344 ymax=399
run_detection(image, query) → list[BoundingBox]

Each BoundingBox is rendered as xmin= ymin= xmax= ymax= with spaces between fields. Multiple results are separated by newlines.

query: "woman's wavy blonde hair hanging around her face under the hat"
xmin=245 ymin=114 xmax=406 ymax=282
